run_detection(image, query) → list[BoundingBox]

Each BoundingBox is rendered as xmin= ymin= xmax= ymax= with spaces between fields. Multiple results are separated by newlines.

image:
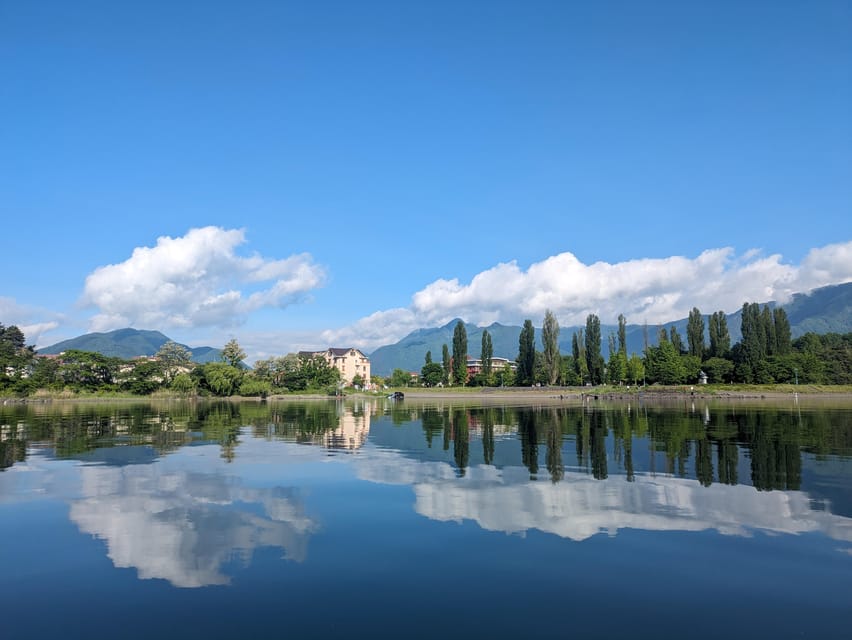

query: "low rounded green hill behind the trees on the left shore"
xmin=38 ymin=328 xmax=222 ymax=364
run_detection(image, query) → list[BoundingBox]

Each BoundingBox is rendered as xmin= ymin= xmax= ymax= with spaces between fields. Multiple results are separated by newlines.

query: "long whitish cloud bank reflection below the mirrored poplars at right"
xmin=359 ymin=455 xmax=852 ymax=543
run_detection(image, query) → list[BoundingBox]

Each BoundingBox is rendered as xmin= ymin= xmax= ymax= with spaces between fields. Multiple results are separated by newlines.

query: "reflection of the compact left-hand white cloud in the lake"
xmin=70 ymin=465 xmax=316 ymax=587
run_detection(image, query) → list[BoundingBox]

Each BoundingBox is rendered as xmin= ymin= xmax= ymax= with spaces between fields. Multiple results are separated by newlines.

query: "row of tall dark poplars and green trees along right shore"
xmin=410 ymin=303 xmax=852 ymax=387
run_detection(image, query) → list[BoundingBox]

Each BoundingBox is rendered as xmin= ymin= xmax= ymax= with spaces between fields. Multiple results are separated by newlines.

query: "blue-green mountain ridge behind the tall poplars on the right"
xmin=370 ymin=282 xmax=852 ymax=376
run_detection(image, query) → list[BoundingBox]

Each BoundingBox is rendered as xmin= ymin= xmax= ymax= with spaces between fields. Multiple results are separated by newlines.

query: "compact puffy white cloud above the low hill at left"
xmin=82 ymin=227 xmax=325 ymax=331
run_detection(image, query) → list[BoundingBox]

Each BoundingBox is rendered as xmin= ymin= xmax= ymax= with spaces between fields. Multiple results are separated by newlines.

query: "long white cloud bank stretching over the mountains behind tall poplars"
xmin=323 ymin=241 xmax=852 ymax=349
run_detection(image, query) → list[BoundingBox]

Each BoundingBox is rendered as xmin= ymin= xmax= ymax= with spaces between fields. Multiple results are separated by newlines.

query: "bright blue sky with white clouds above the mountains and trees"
xmin=0 ymin=0 xmax=852 ymax=362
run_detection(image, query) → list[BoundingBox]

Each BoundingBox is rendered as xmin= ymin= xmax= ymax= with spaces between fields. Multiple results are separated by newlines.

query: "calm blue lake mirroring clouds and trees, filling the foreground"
xmin=0 ymin=398 xmax=852 ymax=640
